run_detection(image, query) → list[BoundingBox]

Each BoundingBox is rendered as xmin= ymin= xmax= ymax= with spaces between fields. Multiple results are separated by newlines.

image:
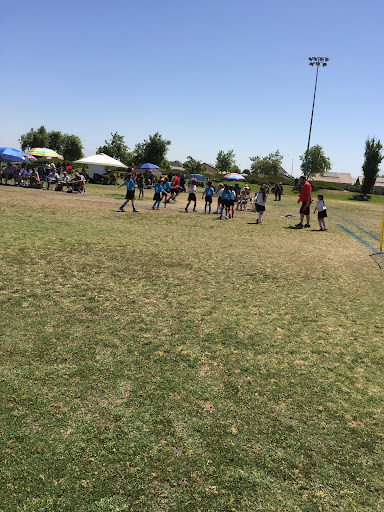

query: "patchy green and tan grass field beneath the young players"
xmin=0 ymin=186 xmax=384 ymax=512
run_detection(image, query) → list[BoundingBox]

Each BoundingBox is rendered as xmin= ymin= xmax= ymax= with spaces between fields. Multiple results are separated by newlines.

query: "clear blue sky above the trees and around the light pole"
xmin=0 ymin=0 xmax=384 ymax=176
